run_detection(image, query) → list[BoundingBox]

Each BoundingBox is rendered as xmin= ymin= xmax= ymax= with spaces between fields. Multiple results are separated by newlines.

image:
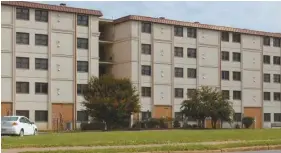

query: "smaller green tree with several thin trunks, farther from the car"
xmin=181 ymin=86 xmax=234 ymax=128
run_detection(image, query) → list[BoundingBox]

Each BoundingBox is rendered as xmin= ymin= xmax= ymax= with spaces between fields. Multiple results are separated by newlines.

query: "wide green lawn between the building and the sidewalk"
xmin=2 ymin=129 xmax=281 ymax=148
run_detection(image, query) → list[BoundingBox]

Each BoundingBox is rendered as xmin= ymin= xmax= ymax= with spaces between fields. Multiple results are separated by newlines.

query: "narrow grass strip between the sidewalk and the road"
xmin=23 ymin=140 xmax=281 ymax=153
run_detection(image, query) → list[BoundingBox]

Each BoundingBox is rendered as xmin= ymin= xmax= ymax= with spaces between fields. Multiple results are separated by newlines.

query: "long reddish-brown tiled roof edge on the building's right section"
xmin=114 ymin=15 xmax=281 ymax=38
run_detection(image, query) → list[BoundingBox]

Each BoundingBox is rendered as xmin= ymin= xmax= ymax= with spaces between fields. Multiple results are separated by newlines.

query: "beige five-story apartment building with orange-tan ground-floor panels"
xmin=1 ymin=2 xmax=281 ymax=129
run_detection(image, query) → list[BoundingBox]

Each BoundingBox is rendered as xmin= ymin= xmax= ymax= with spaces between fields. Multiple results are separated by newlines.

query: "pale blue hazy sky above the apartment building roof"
xmin=43 ymin=1 xmax=281 ymax=33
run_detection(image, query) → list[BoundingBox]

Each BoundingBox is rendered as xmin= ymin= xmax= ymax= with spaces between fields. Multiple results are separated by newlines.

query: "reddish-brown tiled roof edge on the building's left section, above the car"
xmin=1 ymin=1 xmax=102 ymax=17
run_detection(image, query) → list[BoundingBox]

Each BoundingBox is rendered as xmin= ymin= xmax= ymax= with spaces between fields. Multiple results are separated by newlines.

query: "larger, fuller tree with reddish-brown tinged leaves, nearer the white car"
xmin=83 ymin=75 xmax=140 ymax=129
